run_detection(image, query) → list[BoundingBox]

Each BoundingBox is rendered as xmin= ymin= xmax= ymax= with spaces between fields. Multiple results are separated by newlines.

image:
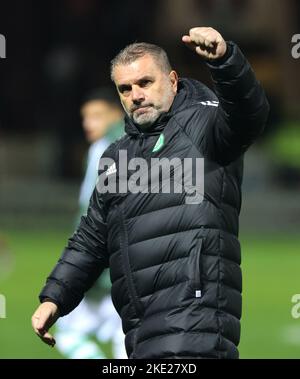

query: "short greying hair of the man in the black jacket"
xmin=110 ymin=42 xmax=172 ymax=81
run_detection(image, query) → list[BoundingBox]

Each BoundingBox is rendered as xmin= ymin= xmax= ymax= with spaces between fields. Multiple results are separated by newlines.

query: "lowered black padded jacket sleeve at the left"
xmin=39 ymin=188 xmax=108 ymax=316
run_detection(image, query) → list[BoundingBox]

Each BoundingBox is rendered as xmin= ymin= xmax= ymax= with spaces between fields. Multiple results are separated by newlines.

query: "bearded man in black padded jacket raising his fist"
xmin=32 ymin=27 xmax=269 ymax=358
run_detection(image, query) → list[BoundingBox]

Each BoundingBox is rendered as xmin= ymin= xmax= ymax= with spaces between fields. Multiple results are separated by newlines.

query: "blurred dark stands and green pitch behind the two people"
xmin=0 ymin=0 xmax=300 ymax=358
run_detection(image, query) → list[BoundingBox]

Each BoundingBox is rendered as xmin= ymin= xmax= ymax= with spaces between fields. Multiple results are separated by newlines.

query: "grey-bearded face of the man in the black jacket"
xmin=113 ymin=54 xmax=178 ymax=128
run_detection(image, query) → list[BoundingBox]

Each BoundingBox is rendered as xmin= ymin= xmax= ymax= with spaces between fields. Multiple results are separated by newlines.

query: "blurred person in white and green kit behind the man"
xmin=55 ymin=87 xmax=127 ymax=359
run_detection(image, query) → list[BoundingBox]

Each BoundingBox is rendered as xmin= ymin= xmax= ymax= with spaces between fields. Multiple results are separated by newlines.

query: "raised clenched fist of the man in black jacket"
xmin=182 ymin=27 xmax=227 ymax=60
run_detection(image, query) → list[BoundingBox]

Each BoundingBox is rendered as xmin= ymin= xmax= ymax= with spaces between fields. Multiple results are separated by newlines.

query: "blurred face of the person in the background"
xmin=81 ymin=100 xmax=122 ymax=143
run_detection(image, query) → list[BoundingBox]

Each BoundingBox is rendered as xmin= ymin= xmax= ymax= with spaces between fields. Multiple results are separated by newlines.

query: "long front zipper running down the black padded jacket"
xmin=119 ymin=207 xmax=144 ymax=317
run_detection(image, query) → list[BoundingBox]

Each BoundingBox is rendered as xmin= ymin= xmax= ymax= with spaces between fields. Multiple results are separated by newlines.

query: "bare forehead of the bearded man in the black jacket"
xmin=114 ymin=54 xmax=162 ymax=85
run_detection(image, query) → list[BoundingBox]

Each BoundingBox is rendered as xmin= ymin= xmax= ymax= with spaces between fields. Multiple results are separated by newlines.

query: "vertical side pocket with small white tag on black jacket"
xmin=189 ymin=238 xmax=203 ymax=298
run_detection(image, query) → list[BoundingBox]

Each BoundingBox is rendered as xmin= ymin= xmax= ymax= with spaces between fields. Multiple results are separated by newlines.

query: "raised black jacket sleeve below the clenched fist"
xmin=203 ymin=42 xmax=269 ymax=164
